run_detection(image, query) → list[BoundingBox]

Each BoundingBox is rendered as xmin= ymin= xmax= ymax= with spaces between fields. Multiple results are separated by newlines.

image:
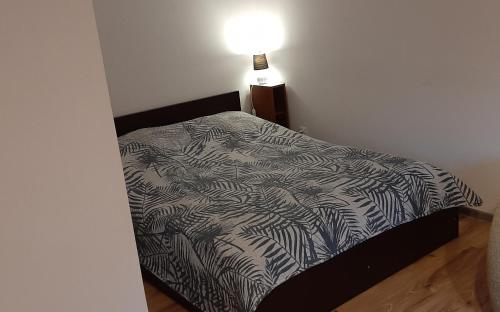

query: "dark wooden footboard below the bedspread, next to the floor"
xmin=257 ymin=208 xmax=458 ymax=312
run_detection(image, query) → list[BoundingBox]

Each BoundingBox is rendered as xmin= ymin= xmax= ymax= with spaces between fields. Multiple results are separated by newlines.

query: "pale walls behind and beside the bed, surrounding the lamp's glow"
xmin=94 ymin=0 xmax=500 ymax=211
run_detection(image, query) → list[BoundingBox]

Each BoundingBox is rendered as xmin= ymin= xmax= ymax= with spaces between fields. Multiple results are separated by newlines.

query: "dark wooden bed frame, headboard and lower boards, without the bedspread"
xmin=115 ymin=91 xmax=458 ymax=312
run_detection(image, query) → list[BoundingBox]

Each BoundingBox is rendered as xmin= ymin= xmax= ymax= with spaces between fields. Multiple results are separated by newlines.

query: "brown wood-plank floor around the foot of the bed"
xmin=144 ymin=216 xmax=492 ymax=312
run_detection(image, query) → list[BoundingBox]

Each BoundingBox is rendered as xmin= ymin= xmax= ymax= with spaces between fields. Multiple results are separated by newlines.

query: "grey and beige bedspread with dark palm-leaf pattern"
xmin=119 ymin=112 xmax=481 ymax=311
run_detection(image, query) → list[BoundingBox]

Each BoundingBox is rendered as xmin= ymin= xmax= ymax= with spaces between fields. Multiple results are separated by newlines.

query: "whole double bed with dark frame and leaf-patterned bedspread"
xmin=115 ymin=92 xmax=481 ymax=311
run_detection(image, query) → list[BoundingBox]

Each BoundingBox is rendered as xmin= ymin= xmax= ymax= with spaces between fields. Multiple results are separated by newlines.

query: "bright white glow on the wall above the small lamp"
xmin=225 ymin=13 xmax=284 ymax=55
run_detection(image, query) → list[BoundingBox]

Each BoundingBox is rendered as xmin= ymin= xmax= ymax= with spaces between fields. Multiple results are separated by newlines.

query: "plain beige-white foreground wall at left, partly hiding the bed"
xmin=0 ymin=0 xmax=147 ymax=312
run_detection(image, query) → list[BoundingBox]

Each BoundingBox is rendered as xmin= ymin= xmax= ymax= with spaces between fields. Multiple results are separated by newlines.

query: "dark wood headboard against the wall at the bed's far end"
xmin=115 ymin=91 xmax=241 ymax=136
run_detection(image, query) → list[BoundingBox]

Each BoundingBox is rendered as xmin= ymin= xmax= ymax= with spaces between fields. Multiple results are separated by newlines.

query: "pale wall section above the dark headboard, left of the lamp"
xmin=94 ymin=0 xmax=292 ymax=116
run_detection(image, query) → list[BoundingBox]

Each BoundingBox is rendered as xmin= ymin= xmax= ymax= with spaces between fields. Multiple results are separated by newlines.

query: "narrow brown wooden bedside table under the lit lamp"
xmin=250 ymin=83 xmax=289 ymax=128
